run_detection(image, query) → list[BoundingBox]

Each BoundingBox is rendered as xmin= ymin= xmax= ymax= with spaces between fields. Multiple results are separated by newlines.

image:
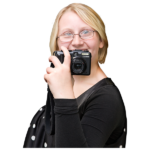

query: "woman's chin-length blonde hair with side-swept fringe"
xmin=48 ymin=2 xmax=109 ymax=65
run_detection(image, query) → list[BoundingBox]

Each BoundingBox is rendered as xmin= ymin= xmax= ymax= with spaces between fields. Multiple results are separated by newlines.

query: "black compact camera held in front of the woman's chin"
xmin=50 ymin=49 xmax=92 ymax=75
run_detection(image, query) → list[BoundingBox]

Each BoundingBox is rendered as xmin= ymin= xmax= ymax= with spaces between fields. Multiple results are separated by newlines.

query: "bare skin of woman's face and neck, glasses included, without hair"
xmin=57 ymin=10 xmax=108 ymax=85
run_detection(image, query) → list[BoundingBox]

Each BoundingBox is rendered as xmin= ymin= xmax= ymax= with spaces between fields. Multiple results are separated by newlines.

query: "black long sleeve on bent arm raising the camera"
xmin=54 ymin=89 xmax=121 ymax=149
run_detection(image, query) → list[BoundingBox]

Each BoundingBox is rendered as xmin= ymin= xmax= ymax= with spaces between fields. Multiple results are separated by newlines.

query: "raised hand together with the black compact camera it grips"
xmin=43 ymin=46 xmax=91 ymax=99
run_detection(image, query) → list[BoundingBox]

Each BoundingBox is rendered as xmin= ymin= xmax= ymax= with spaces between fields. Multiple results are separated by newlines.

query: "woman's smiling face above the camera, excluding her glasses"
xmin=57 ymin=11 xmax=103 ymax=66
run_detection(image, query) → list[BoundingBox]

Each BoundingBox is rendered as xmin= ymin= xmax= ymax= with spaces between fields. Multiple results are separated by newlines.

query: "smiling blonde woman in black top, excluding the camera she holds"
xmin=23 ymin=2 xmax=127 ymax=149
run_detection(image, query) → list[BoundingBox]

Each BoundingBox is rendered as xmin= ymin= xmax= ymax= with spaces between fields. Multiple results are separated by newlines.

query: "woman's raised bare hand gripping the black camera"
xmin=43 ymin=46 xmax=75 ymax=99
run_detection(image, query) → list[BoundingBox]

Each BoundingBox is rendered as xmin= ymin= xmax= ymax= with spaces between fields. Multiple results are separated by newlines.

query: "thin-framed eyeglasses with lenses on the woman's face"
xmin=56 ymin=30 xmax=97 ymax=42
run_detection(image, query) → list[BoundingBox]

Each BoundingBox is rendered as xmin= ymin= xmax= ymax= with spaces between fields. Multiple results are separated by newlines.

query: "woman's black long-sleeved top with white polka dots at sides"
xmin=23 ymin=77 xmax=128 ymax=149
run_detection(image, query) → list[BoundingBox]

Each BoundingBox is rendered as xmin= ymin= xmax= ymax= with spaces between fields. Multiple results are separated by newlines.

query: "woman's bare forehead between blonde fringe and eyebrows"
xmin=59 ymin=11 xmax=92 ymax=31
